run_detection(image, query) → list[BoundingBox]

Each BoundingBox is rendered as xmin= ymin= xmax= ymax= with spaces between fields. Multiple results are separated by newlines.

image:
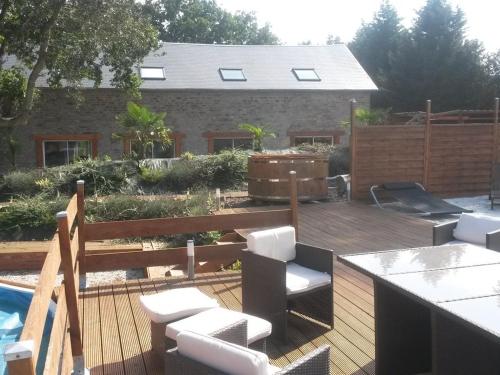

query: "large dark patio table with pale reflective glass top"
xmin=338 ymin=245 xmax=500 ymax=375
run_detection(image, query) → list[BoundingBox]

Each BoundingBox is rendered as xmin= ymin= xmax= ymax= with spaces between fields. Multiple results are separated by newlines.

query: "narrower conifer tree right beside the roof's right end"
xmin=349 ymin=1 xmax=407 ymax=107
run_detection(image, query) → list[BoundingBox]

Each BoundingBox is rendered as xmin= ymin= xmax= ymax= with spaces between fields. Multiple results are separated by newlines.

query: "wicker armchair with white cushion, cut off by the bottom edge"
xmin=165 ymin=326 xmax=330 ymax=375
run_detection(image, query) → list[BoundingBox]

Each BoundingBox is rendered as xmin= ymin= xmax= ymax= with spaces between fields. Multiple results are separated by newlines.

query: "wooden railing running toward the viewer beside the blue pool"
xmin=7 ymin=181 xmax=83 ymax=375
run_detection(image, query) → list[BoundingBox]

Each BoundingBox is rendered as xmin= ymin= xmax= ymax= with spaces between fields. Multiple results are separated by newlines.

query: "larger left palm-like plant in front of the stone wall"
xmin=113 ymin=102 xmax=171 ymax=159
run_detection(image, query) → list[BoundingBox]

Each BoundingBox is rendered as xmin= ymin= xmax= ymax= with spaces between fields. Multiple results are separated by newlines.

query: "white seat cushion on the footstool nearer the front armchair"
xmin=165 ymin=307 xmax=272 ymax=344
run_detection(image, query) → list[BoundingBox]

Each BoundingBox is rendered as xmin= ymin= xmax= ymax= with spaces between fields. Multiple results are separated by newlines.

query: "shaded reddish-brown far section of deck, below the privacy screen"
xmin=227 ymin=202 xmax=433 ymax=255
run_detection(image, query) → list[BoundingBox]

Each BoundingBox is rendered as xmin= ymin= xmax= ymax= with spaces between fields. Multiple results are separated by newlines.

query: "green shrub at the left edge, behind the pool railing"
xmin=0 ymin=194 xmax=69 ymax=240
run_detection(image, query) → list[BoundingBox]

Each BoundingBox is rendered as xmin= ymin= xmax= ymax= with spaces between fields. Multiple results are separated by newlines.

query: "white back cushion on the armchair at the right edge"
xmin=453 ymin=213 xmax=500 ymax=245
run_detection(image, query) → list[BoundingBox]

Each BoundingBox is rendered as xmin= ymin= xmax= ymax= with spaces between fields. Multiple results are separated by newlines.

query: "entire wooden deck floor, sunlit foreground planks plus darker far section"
xmin=79 ymin=203 xmax=431 ymax=375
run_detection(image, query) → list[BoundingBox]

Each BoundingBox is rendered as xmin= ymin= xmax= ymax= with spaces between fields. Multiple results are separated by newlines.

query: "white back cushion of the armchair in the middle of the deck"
xmin=247 ymin=226 xmax=296 ymax=262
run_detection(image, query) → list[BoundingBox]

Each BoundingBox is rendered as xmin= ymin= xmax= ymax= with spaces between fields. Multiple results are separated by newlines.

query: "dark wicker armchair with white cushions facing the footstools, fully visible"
xmin=242 ymin=228 xmax=334 ymax=342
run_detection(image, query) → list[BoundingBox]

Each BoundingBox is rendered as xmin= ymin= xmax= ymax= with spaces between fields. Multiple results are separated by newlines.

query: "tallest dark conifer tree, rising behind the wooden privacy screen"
xmin=394 ymin=0 xmax=486 ymax=111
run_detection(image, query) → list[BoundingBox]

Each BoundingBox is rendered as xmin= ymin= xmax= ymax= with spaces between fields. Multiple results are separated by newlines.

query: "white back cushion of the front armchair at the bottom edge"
xmin=177 ymin=331 xmax=269 ymax=375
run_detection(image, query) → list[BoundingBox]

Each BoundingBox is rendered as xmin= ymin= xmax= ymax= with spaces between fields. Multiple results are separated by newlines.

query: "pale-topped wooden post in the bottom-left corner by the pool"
xmin=3 ymin=340 xmax=36 ymax=375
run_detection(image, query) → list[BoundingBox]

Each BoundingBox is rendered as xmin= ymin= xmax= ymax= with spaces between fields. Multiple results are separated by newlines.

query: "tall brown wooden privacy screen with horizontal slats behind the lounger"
xmin=351 ymin=123 xmax=500 ymax=199
